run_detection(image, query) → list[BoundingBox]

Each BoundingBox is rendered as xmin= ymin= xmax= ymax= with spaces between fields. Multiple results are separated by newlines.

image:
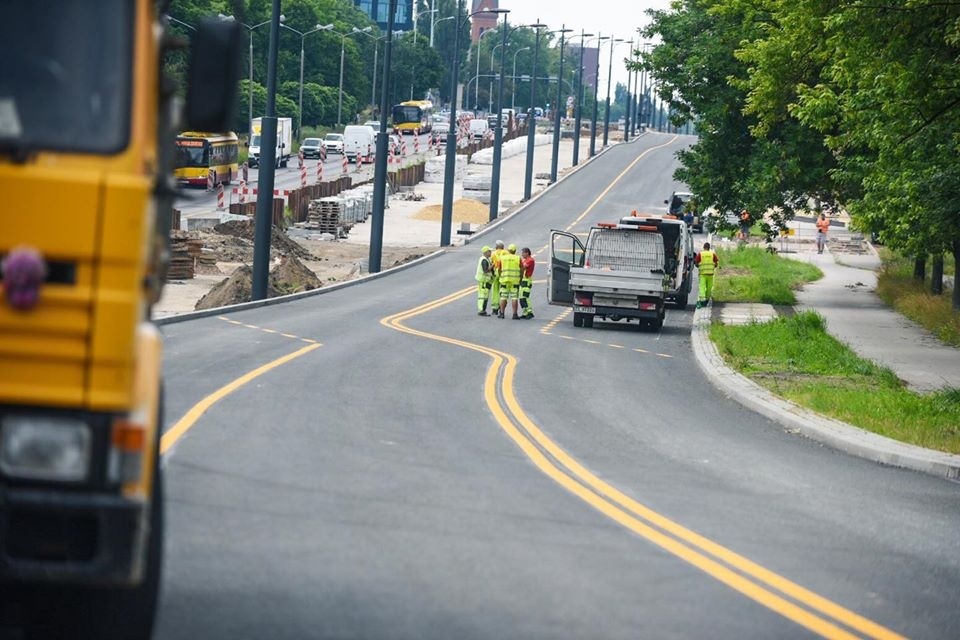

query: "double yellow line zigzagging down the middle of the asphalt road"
xmin=380 ymin=287 xmax=902 ymax=640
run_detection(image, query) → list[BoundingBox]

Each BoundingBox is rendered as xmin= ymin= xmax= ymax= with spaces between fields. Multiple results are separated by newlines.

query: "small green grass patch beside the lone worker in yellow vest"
xmin=713 ymin=247 xmax=823 ymax=305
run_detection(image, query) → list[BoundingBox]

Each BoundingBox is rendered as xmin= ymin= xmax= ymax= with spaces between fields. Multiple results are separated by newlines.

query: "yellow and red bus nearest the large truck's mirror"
xmin=174 ymin=131 xmax=240 ymax=187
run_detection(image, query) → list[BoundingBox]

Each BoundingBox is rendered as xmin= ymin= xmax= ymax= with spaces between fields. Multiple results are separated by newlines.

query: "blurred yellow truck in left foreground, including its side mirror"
xmin=0 ymin=0 xmax=240 ymax=640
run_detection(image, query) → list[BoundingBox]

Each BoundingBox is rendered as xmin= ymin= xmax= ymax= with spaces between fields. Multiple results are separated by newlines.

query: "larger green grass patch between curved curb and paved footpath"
xmin=710 ymin=312 xmax=960 ymax=453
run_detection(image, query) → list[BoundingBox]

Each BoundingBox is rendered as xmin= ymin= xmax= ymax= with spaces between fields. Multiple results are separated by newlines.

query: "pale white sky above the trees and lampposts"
xmin=476 ymin=0 xmax=670 ymax=84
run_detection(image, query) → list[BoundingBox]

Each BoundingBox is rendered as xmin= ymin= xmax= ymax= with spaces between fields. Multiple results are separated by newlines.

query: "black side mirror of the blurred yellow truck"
xmin=184 ymin=18 xmax=241 ymax=131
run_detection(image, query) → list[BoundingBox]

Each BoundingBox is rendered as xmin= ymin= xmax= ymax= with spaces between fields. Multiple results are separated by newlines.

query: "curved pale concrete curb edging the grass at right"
xmin=691 ymin=306 xmax=960 ymax=480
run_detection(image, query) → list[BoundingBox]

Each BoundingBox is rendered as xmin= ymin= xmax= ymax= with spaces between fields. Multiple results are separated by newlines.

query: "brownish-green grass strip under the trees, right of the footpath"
xmin=877 ymin=251 xmax=960 ymax=347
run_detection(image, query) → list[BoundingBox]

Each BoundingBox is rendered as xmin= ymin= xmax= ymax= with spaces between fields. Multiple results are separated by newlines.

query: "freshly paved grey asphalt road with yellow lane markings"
xmin=156 ymin=134 xmax=960 ymax=640
